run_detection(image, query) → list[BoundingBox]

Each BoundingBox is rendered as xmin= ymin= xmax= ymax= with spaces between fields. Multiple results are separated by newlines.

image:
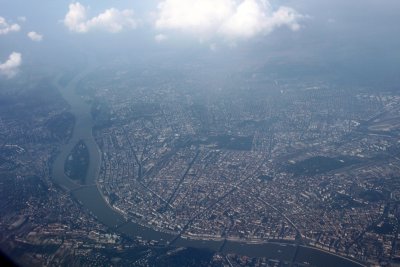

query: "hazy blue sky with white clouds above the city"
xmin=0 ymin=0 xmax=400 ymax=85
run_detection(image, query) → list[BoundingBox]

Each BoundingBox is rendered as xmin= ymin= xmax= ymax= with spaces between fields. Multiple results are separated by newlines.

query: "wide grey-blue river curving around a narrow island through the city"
xmin=52 ymin=69 xmax=363 ymax=267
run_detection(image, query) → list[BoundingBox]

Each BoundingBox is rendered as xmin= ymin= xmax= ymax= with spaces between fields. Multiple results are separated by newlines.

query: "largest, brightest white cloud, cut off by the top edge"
xmin=155 ymin=0 xmax=304 ymax=39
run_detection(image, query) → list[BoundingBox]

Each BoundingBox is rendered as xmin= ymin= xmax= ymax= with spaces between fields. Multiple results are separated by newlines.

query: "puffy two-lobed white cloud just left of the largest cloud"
xmin=64 ymin=2 xmax=137 ymax=33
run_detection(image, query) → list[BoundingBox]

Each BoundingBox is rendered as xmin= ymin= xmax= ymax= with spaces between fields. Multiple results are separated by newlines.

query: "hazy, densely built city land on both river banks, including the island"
xmin=0 ymin=62 xmax=400 ymax=266
